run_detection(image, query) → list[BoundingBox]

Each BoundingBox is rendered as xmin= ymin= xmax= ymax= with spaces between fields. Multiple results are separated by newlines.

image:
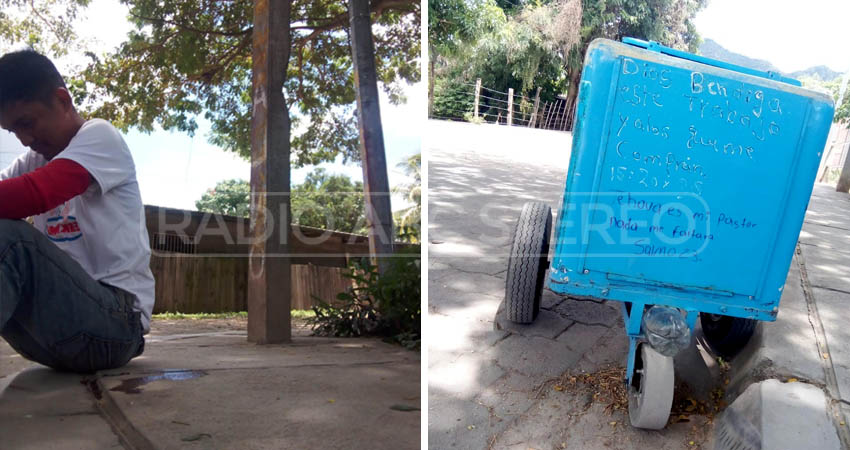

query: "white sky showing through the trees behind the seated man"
xmin=0 ymin=0 xmax=425 ymax=210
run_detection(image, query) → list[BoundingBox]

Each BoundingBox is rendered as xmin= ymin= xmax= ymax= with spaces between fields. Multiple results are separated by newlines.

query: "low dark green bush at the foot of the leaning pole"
xmin=308 ymin=246 xmax=422 ymax=350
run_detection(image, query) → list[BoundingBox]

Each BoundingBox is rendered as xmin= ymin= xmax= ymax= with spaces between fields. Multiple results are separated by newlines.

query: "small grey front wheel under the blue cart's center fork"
xmin=629 ymin=344 xmax=673 ymax=430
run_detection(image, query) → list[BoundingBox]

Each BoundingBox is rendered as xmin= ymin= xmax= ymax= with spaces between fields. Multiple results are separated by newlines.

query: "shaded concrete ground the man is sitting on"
xmin=0 ymin=331 xmax=421 ymax=449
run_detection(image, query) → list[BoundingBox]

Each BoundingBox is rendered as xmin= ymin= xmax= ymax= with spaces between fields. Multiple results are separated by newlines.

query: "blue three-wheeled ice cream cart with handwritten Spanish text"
xmin=505 ymin=38 xmax=834 ymax=429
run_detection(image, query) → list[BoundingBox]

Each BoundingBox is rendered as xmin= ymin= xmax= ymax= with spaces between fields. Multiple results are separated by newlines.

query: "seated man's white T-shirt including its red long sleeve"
xmin=0 ymin=119 xmax=154 ymax=333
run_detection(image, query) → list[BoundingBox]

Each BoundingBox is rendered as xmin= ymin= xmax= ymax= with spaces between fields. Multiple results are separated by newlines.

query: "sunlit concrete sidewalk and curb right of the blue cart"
xmin=718 ymin=185 xmax=850 ymax=449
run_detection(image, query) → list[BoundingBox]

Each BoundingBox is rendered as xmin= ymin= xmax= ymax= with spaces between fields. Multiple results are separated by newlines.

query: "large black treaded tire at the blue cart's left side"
xmin=505 ymin=202 xmax=552 ymax=323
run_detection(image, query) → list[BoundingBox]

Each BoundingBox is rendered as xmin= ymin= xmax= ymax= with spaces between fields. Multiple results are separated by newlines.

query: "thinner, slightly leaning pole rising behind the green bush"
xmin=348 ymin=0 xmax=393 ymax=273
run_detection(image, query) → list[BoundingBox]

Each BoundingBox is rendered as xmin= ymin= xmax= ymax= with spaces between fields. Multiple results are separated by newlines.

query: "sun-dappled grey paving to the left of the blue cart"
xmin=426 ymin=121 xmax=713 ymax=449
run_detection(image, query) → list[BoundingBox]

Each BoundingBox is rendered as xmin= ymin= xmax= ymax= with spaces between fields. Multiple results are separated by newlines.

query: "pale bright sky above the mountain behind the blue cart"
xmin=694 ymin=0 xmax=850 ymax=72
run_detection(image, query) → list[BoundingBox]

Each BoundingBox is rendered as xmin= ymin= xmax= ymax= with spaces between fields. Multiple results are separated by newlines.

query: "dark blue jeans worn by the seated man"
xmin=0 ymin=219 xmax=145 ymax=373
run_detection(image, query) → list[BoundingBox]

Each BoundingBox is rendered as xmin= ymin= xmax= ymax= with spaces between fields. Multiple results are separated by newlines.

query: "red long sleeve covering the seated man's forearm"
xmin=0 ymin=159 xmax=92 ymax=219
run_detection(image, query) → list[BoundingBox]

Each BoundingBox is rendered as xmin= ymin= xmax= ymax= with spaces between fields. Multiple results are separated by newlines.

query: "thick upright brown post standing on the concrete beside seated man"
xmin=248 ymin=0 xmax=292 ymax=344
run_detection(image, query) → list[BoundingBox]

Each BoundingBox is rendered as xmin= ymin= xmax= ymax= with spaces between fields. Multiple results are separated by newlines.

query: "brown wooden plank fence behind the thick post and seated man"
xmin=145 ymin=205 xmax=407 ymax=313
